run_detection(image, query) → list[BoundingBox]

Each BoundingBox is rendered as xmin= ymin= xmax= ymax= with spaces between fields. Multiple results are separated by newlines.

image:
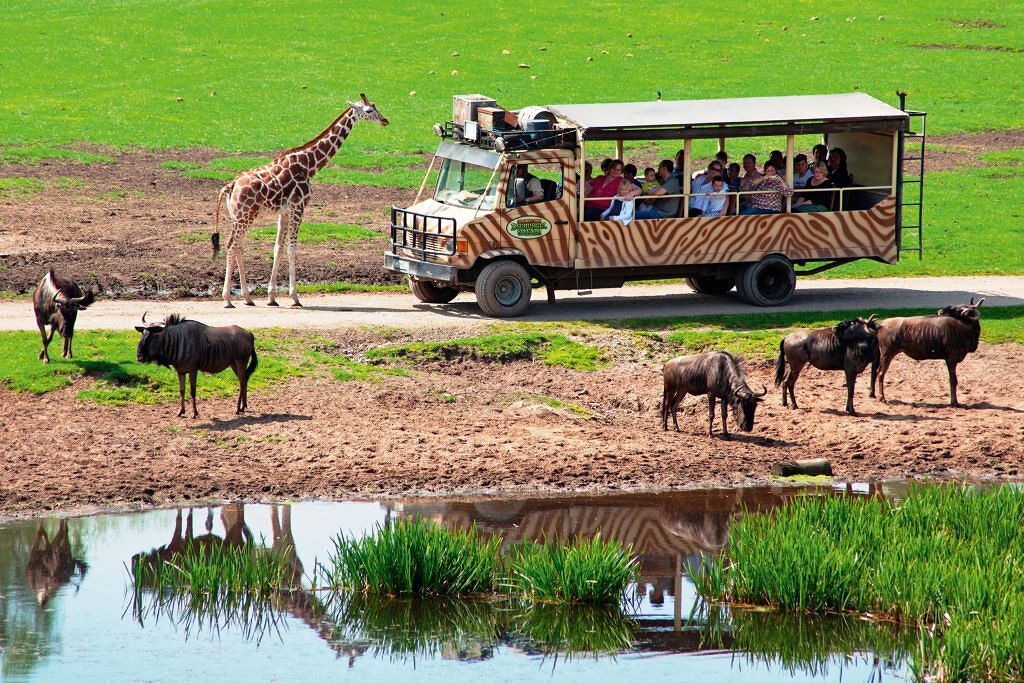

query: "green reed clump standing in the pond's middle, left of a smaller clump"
xmin=317 ymin=516 xmax=501 ymax=595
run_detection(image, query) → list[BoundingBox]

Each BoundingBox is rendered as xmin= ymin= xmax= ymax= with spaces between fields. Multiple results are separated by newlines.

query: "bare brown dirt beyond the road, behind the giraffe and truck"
xmin=0 ymin=130 xmax=1024 ymax=299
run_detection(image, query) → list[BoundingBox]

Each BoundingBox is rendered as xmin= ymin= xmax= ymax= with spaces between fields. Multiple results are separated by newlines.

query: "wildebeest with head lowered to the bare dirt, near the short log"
xmin=662 ymin=351 xmax=768 ymax=438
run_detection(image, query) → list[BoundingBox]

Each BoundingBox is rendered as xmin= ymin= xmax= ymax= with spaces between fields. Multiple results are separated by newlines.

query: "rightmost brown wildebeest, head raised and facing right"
xmin=871 ymin=297 xmax=985 ymax=407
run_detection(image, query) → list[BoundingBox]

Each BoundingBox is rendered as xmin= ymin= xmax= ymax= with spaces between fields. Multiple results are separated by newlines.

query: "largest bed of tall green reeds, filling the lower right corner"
xmin=695 ymin=486 xmax=1024 ymax=680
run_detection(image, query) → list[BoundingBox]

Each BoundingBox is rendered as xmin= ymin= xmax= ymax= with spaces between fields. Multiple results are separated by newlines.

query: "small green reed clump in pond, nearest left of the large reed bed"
xmin=506 ymin=533 xmax=637 ymax=604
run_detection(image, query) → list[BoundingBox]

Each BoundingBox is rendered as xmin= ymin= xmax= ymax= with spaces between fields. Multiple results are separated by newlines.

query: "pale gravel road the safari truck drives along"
xmin=0 ymin=275 xmax=1024 ymax=330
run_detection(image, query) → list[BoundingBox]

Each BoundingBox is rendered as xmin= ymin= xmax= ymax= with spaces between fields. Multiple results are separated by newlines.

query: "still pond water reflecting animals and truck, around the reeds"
xmin=0 ymin=484 xmax=916 ymax=683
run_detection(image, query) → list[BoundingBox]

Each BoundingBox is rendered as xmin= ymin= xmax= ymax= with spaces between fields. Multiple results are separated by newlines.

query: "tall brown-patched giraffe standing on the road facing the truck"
xmin=211 ymin=93 xmax=388 ymax=308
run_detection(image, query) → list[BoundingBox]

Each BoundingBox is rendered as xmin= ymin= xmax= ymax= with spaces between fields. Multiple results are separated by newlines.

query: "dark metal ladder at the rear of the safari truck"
xmin=896 ymin=91 xmax=928 ymax=260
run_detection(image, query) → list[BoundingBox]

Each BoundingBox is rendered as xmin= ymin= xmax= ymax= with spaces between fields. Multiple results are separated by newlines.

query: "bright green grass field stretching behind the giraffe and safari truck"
xmin=0 ymin=0 xmax=1024 ymax=278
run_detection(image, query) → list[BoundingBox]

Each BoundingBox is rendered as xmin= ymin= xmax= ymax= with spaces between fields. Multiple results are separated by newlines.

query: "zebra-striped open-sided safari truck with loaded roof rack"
xmin=385 ymin=92 xmax=926 ymax=317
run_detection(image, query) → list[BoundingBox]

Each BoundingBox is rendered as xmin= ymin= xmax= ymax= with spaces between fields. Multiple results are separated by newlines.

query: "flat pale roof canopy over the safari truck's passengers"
xmin=547 ymin=92 xmax=909 ymax=140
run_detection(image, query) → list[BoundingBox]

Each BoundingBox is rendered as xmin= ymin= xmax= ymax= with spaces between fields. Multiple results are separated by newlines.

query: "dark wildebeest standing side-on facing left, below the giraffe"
xmin=135 ymin=313 xmax=257 ymax=418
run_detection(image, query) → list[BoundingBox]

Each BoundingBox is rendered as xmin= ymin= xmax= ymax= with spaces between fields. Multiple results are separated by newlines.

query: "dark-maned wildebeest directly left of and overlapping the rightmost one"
xmin=775 ymin=315 xmax=878 ymax=415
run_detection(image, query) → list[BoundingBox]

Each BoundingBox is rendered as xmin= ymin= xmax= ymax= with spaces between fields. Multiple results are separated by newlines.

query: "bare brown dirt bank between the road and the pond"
xmin=0 ymin=332 xmax=1024 ymax=516
